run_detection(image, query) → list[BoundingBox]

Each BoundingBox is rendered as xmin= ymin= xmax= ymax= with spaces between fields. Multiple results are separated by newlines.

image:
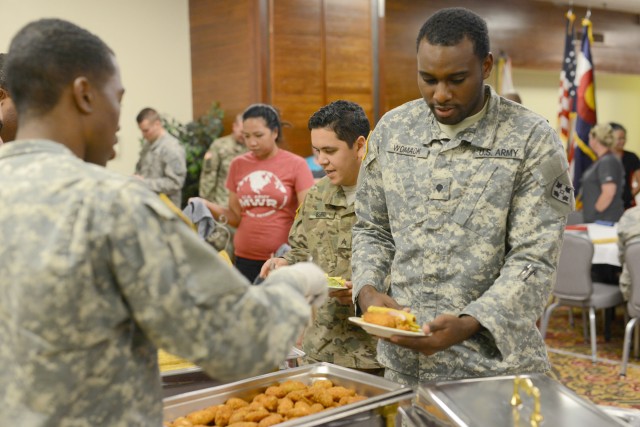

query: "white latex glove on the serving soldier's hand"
xmin=264 ymin=262 xmax=329 ymax=307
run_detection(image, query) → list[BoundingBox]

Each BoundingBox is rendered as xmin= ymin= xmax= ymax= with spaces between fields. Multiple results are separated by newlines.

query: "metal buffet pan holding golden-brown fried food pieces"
xmin=164 ymin=363 xmax=413 ymax=427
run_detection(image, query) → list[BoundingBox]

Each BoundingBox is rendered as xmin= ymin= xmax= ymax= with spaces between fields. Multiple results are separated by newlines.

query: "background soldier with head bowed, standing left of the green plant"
xmin=135 ymin=108 xmax=187 ymax=207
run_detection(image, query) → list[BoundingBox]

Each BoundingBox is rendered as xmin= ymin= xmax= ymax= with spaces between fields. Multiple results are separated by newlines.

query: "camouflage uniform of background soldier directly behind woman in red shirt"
xmin=199 ymin=135 xmax=248 ymax=206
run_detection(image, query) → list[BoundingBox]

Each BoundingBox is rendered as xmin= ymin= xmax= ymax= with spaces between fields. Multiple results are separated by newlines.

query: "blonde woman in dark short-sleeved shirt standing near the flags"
xmin=581 ymin=124 xmax=624 ymax=223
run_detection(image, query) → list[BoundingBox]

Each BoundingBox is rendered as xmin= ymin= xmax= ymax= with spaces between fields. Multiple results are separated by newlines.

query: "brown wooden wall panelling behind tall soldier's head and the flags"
xmin=381 ymin=0 xmax=640 ymax=111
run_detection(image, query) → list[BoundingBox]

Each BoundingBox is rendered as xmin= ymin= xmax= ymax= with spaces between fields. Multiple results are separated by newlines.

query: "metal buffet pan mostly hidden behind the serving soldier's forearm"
xmin=160 ymin=347 xmax=305 ymax=397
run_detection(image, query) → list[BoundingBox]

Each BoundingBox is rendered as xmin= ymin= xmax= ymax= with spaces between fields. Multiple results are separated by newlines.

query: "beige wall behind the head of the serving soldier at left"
xmin=0 ymin=0 xmax=192 ymax=174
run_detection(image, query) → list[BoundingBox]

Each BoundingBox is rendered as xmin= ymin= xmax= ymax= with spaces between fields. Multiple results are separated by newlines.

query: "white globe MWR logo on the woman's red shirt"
xmin=236 ymin=171 xmax=289 ymax=218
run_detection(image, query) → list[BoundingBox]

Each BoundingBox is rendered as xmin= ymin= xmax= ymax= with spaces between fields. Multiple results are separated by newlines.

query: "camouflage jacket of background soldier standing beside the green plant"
xmin=136 ymin=132 xmax=187 ymax=208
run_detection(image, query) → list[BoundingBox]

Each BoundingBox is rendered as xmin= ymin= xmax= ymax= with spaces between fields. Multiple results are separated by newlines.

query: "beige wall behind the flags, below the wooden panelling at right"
xmin=504 ymin=69 xmax=640 ymax=155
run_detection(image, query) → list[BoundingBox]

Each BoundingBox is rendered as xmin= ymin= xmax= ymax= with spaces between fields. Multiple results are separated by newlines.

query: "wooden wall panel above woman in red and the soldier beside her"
xmin=270 ymin=0 xmax=373 ymax=156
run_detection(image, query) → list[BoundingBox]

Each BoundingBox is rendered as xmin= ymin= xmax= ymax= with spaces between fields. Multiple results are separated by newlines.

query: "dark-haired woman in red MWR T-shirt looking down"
xmin=198 ymin=104 xmax=314 ymax=282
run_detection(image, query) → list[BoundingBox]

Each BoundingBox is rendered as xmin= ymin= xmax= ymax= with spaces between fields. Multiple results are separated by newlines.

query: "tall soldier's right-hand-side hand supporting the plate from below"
xmin=389 ymin=314 xmax=481 ymax=356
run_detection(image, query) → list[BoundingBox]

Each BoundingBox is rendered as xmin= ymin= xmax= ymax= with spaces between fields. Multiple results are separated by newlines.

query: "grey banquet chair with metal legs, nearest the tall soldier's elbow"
xmin=540 ymin=233 xmax=624 ymax=363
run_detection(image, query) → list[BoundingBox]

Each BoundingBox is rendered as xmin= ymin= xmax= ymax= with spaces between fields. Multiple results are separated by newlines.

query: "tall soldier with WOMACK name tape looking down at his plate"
xmin=352 ymin=8 xmax=574 ymax=385
